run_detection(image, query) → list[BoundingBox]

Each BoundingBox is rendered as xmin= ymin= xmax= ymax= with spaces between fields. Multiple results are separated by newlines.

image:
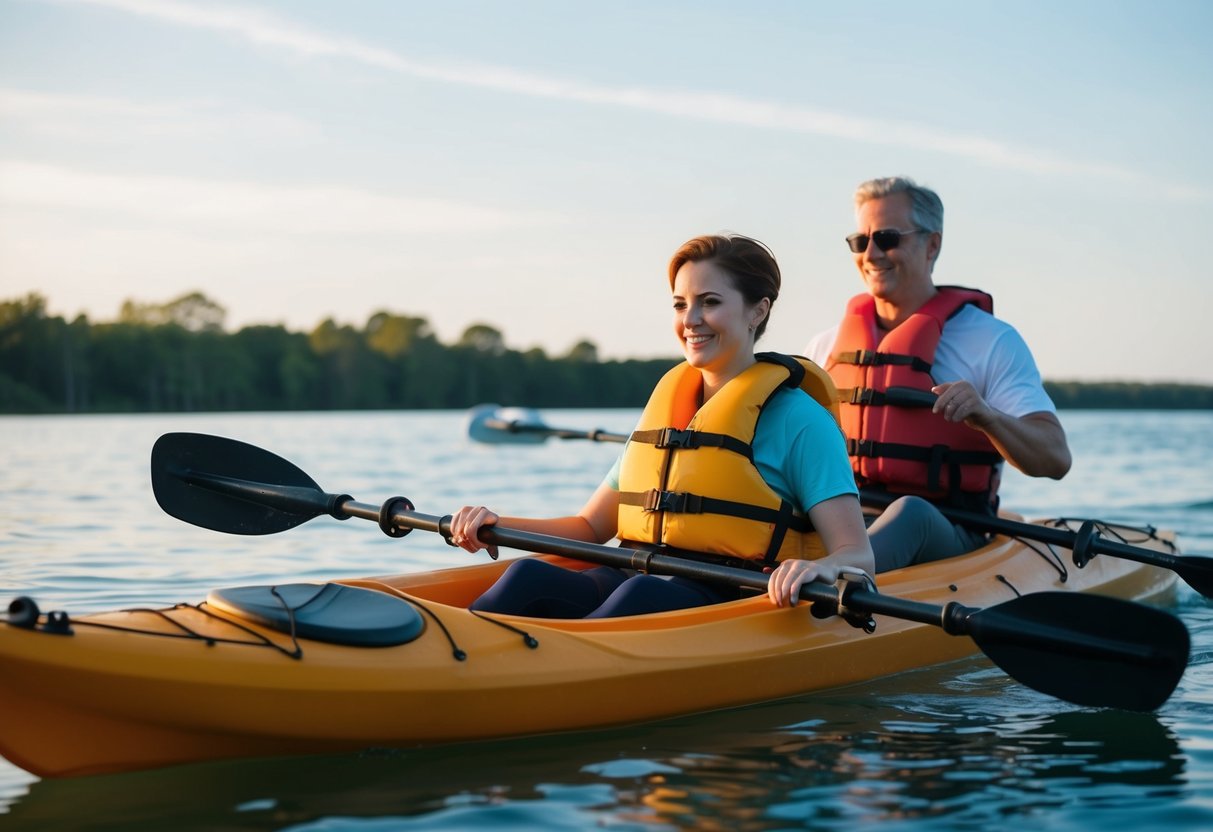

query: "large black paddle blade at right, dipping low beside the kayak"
xmin=968 ymin=592 xmax=1189 ymax=711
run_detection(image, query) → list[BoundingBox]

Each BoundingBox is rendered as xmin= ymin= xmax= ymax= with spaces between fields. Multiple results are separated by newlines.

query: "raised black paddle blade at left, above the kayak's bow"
xmin=152 ymin=433 xmax=349 ymax=535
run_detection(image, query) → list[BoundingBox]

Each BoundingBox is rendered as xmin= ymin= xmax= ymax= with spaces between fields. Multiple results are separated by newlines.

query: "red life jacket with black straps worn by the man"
xmin=825 ymin=286 xmax=1002 ymax=511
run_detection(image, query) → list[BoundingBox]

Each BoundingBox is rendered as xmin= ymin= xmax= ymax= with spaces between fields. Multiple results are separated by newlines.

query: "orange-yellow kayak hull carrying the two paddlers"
xmin=0 ymin=521 xmax=1175 ymax=777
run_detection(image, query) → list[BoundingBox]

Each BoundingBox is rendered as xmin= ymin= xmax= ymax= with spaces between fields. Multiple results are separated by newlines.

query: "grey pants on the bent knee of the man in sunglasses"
xmin=867 ymin=497 xmax=987 ymax=572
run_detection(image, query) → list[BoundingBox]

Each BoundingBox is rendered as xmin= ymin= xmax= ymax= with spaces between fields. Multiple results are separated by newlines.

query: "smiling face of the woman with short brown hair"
xmin=673 ymin=260 xmax=769 ymax=381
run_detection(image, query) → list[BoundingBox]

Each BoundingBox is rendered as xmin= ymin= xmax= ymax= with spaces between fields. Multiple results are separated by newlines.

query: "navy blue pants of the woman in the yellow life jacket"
xmin=471 ymin=558 xmax=736 ymax=619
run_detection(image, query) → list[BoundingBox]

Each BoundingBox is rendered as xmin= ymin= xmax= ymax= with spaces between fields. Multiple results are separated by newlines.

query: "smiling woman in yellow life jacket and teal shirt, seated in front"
xmin=450 ymin=235 xmax=873 ymax=617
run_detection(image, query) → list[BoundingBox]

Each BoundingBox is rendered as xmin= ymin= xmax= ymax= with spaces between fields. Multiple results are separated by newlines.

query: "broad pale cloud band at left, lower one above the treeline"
xmin=0 ymin=160 xmax=557 ymax=234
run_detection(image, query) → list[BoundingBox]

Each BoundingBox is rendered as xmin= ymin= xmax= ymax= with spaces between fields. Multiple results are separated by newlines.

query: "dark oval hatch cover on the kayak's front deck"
xmin=206 ymin=583 xmax=425 ymax=648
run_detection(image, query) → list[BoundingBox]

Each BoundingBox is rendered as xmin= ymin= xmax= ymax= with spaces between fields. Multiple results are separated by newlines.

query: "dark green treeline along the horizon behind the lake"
xmin=0 ymin=292 xmax=1213 ymax=414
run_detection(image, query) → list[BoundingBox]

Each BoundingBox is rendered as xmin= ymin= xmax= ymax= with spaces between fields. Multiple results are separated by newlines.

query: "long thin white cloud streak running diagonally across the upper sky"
xmin=59 ymin=0 xmax=1211 ymax=200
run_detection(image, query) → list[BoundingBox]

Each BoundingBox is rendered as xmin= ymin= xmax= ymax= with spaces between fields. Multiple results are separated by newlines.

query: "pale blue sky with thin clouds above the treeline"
xmin=0 ymin=0 xmax=1213 ymax=383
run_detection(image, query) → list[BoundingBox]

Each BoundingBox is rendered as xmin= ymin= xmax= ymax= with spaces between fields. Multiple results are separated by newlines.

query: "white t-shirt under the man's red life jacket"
xmin=804 ymin=304 xmax=1057 ymax=418
